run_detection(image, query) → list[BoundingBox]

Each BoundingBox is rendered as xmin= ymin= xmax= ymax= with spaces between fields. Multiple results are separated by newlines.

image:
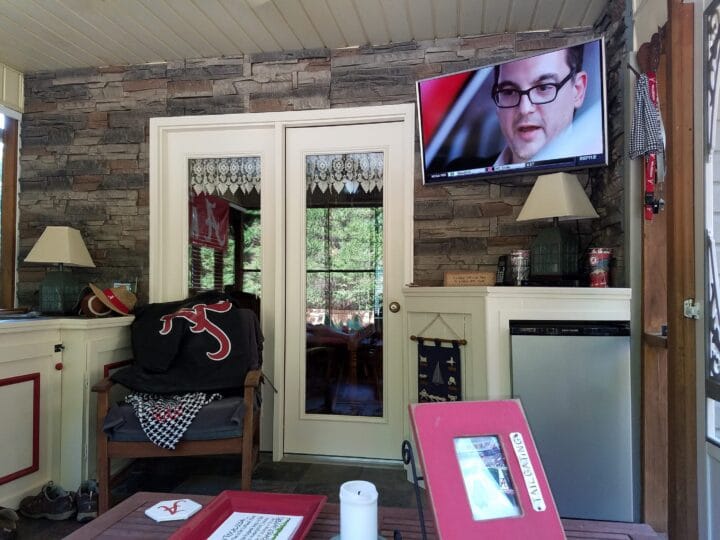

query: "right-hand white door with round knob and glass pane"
xmin=283 ymin=122 xmax=412 ymax=459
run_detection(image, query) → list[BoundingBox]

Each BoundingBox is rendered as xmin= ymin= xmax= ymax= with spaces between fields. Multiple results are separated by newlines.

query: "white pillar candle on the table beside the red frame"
xmin=340 ymin=480 xmax=378 ymax=540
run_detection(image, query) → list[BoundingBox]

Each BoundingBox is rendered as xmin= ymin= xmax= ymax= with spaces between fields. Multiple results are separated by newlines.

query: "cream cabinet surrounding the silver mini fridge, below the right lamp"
xmin=403 ymin=287 xmax=630 ymax=403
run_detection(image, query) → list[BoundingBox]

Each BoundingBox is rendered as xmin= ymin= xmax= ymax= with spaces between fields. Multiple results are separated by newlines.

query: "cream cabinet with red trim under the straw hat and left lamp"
xmin=0 ymin=317 xmax=133 ymax=508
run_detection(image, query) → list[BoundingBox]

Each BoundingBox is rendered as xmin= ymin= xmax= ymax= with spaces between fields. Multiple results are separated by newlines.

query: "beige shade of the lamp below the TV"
xmin=517 ymin=173 xmax=598 ymax=221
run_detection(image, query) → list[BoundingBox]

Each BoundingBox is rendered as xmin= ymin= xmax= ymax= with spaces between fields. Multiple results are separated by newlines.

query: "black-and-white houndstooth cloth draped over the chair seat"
xmin=125 ymin=392 xmax=222 ymax=450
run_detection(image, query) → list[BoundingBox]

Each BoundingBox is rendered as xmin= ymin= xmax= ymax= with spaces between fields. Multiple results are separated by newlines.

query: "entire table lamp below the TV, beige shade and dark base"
xmin=517 ymin=173 xmax=598 ymax=283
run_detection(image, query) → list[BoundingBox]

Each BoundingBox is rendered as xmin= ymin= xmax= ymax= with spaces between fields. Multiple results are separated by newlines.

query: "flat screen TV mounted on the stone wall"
xmin=417 ymin=38 xmax=607 ymax=184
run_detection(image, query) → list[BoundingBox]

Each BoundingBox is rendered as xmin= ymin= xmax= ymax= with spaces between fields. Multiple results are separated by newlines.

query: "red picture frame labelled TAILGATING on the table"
xmin=410 ymin=400 xmax=565 ymax=540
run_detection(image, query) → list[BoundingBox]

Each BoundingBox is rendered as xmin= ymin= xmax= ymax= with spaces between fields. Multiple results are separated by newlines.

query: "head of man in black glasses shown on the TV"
xmin=492 ymin=45 xmax=588 ymax=166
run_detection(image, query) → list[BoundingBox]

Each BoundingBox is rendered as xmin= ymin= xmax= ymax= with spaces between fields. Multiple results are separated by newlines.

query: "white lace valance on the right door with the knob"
xmin=306 ymin=152 xmax=385 ymax=193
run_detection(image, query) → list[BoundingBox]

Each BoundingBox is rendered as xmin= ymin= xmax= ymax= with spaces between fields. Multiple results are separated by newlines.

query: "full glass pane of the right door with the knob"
xmin=305 ymin=152 xmax=384 ymax=417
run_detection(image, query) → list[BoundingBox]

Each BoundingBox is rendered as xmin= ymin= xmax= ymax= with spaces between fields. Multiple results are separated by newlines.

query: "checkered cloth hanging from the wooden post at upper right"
xmin=630 ymin=73 xmax=665 ymax=159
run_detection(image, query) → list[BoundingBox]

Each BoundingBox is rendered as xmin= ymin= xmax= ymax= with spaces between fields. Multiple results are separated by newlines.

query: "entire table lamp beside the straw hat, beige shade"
xmin=25 ymin=226 xmax=95 ymax=314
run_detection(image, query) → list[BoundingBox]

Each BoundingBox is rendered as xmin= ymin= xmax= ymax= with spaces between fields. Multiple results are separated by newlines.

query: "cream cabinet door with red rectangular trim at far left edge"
xmin=0 ymin=329 xmax=61 ymax=508
